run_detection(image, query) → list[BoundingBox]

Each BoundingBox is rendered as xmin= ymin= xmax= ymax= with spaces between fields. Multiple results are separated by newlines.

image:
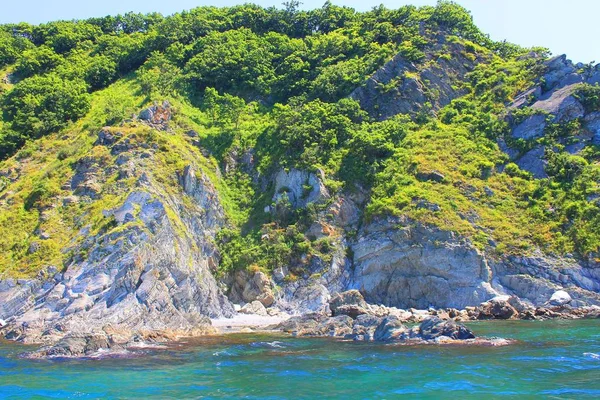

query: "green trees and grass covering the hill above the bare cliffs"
xmin=0 ymin=1 xmax=600 ymax=276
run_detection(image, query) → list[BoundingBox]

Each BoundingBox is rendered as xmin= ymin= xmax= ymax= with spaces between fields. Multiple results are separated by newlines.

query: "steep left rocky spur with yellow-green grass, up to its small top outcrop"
xmin=0 ymin=90 xmax=233 ymax=343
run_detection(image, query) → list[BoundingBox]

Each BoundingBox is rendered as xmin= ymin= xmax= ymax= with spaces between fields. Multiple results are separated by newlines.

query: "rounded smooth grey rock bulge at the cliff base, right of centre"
xmin=351 ymin=219 xmax=498 ymax=309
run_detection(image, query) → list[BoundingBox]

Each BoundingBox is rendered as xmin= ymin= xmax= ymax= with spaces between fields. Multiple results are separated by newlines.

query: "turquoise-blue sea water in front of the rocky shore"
xmin=0 ymin=320 xmax=600 ymax=399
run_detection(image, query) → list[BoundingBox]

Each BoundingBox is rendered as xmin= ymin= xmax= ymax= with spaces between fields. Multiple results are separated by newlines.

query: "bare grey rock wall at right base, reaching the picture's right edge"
xmin=348 ymin=218 xmax=600 ymax=310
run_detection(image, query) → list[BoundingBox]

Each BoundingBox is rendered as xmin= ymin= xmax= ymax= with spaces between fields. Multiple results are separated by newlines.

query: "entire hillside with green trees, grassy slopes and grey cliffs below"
xmin=0 ymin=1 xmax=600 ymax=350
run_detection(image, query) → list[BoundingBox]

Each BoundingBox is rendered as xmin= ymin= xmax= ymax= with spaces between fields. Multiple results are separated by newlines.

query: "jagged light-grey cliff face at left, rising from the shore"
xmin=0 ymin=111 xmax=234 ymax=343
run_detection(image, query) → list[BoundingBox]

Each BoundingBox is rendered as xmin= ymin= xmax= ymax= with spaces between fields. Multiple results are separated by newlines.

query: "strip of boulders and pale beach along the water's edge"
xmin=0 ymin=290 xmax=600 ymax=358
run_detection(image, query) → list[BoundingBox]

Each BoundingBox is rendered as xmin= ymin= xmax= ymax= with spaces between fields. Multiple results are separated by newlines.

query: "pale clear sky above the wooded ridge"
xmin=0 ymin=0 xmax=600 ymax=63
